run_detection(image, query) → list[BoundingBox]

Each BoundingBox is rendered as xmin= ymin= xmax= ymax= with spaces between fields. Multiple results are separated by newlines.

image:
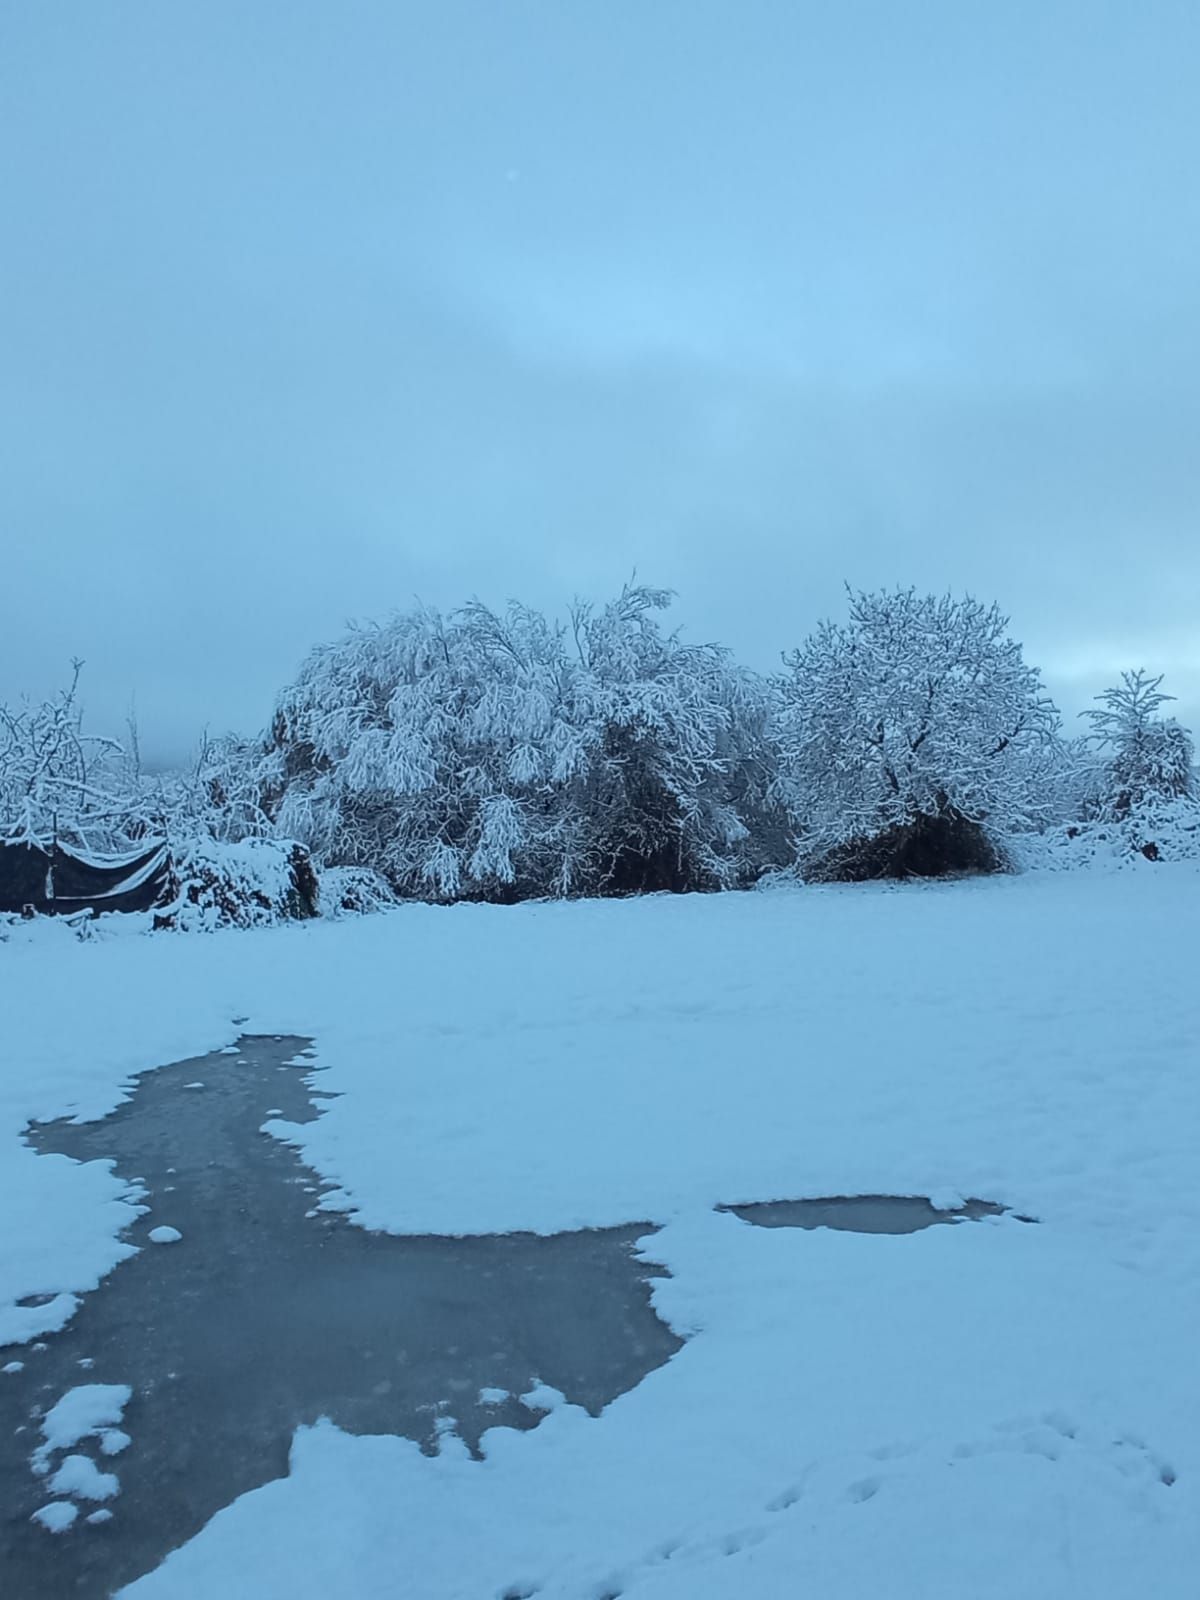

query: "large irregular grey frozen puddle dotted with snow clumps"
xmin=0 ymin=1037 xmax=680 ymax=1600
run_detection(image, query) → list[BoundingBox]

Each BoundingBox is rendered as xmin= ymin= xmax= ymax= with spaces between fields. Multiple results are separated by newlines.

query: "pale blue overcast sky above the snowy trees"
xmin=0 ymin=0 xmax=1200 ymax=763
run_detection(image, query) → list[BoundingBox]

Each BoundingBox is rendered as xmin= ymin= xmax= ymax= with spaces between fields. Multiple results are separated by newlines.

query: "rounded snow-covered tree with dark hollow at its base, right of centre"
xmin=776 ymin=589 xmax=1058 ymax=877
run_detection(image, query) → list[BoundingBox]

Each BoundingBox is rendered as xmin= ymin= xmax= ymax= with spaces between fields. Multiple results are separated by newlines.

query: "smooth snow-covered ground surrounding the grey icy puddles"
xmin=0 ymin=866 xmax=1200 ymax=1600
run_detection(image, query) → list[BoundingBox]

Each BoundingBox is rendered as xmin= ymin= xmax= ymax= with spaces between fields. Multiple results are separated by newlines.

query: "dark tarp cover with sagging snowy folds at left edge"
xmin=0 ymin=840 xmax=171 ymax=914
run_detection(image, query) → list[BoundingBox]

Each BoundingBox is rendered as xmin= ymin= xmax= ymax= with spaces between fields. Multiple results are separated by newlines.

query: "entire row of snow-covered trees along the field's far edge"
xmin=0 ymin=584 xmax=1200 ymax=902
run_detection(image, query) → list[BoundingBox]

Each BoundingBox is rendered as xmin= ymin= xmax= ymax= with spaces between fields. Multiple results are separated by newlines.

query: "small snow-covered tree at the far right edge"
xmin=1083 ymin=667 xmax=1195 ymax=819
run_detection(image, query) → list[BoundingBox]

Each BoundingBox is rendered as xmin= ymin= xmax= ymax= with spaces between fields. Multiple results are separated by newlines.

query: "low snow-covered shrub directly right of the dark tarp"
xmin=154 ymin=837 xmax=320 ymax=933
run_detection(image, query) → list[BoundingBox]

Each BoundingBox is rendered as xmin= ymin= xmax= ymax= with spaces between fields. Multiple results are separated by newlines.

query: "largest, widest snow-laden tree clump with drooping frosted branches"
xmin=261 ymin=587 xmax=784 ymax=901
